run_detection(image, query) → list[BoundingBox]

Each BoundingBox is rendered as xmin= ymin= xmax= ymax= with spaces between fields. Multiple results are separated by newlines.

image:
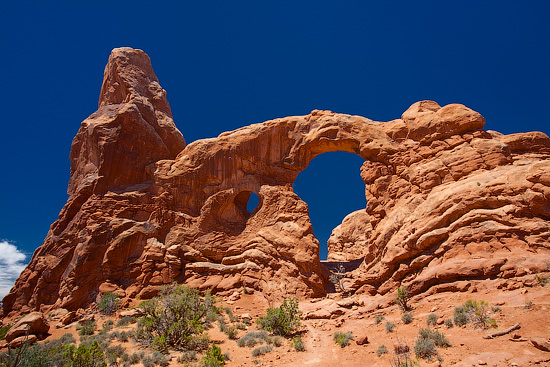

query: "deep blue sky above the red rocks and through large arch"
xmin=0 ymin=1 xmax=550 ymax=294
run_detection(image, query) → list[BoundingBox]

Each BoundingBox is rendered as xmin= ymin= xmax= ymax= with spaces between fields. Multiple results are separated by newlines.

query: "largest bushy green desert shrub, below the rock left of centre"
xmin=135 ymin=284 xmax=219 ymax=348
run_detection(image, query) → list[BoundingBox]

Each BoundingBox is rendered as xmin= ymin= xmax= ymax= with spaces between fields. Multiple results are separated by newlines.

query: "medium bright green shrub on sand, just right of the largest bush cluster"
xmin=256 ymin=298 xmax=302 ymax=336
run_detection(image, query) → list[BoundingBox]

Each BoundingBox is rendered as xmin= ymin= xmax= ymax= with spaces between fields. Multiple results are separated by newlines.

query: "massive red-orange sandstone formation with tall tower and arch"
xmin=3 ymin=48 xmax=550 ymax=315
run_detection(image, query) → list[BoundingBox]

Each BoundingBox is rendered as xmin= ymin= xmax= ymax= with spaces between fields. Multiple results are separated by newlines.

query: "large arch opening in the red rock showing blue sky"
xmin=293 ymin=152 xmax=367 ymax=260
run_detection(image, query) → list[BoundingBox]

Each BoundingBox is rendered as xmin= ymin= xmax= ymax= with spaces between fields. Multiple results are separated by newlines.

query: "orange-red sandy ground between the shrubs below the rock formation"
xmin=4 ymin=282 xmax=550 ymax=367
